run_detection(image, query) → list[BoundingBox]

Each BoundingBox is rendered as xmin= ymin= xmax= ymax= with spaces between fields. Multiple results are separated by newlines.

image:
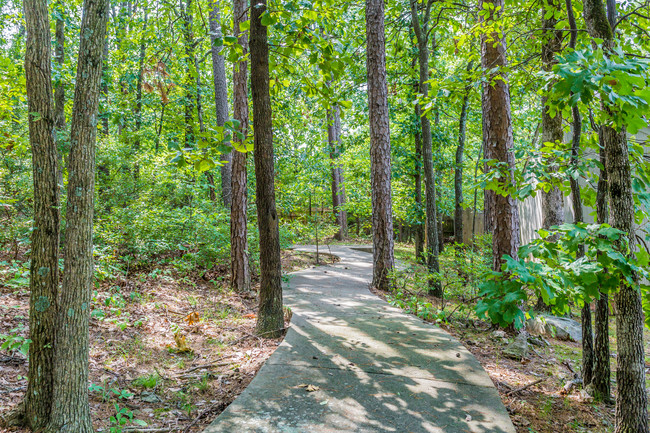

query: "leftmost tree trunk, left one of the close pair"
xmin=3 ymin=0 xmax=59 ymax=431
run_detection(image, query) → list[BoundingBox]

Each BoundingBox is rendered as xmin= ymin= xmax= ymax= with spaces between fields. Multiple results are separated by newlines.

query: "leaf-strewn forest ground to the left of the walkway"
xmin=0 ymin=251 xmax=331 ymax=433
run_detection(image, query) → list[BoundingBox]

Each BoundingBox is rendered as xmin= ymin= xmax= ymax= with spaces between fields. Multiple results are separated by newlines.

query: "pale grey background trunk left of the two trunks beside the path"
xmin=210 ymin=0 xmax=232 ymax=208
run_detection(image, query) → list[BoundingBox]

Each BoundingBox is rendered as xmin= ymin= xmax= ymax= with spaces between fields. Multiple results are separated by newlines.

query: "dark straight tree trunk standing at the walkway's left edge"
xmin=250 ymin=0 xmax=284 ymax=338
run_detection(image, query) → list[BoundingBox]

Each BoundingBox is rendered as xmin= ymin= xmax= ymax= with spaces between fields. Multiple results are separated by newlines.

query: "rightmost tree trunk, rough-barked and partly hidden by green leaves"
xmin=583 ymin=0 xmax=648 ymax=433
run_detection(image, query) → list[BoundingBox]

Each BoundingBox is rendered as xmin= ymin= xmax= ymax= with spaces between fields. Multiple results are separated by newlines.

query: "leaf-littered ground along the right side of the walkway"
xmin=377 ymin=245 xmax=650 ymax=433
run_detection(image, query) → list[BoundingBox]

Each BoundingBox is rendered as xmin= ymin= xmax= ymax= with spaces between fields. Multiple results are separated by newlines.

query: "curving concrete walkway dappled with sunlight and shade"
xmin=205 ymin=246 xmax=515 ymax=433
